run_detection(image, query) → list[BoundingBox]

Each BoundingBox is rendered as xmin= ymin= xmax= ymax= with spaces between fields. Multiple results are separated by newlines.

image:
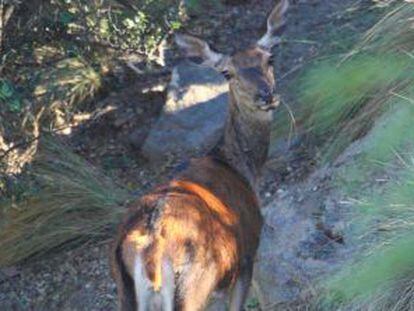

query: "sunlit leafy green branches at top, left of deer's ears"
xmin=51 ymin=0 xmax=181 ymax=54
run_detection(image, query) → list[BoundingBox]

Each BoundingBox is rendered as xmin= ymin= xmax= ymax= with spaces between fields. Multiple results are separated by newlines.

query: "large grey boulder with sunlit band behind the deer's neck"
xmin=142 ymin=62 xmax=228 ymax=162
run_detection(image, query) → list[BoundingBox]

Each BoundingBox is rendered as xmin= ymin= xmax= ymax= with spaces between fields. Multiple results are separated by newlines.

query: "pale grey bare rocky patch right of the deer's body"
xmin=254 ymin=172 xmax=345 ymax=310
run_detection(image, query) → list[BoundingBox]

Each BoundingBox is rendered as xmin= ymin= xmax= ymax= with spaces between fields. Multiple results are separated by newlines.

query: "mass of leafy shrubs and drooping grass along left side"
xmin=0 ymin=0 xmax=209 ymax=266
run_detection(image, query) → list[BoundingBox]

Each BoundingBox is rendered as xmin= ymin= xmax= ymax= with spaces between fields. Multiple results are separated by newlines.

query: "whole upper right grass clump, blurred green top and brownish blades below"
xmin=300 ymin=53 xmax=414 ymax=160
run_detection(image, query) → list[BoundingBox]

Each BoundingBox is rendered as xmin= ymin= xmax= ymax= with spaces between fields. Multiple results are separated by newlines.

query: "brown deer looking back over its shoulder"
xmin=111 ymin=0 xmax=288 ymax=311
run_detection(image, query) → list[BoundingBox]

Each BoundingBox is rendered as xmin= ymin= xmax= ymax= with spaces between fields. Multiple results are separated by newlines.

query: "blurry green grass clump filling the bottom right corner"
xmin=322 ymin=154 xmax=414 ymax=310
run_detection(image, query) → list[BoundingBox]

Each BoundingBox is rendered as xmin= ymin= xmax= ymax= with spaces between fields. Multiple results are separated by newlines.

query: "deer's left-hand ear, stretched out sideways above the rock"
xmin=175 ymin=34 xmax=228 ymax=71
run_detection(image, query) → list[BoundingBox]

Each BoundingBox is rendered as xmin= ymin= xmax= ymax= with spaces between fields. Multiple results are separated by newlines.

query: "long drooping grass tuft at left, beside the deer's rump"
xmin=0 ymin=138 xmax=129 ymax=266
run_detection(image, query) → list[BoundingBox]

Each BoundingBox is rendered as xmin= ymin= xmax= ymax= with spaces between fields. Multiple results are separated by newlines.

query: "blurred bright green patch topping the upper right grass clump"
xmin=301 ymin=55 xmax=409 ymax=135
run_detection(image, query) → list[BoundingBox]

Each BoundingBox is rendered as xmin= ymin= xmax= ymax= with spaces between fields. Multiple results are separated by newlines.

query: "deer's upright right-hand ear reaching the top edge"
xmin=257 ymin=0 xmax=289 ymax=50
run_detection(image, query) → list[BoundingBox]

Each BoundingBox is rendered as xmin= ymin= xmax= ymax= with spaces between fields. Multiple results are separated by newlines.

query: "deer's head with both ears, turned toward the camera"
xmin=175 ymin=0 xmax=289 ymax=112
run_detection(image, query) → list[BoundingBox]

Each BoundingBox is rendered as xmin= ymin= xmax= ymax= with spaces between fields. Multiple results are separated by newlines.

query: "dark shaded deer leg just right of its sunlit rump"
xmin=229 ymin=259 xmax=253 ymax=311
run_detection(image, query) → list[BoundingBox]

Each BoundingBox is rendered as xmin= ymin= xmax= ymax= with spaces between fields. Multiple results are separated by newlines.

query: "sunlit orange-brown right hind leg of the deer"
xmin=178 ymin=263 xmax=217 ymax=311
